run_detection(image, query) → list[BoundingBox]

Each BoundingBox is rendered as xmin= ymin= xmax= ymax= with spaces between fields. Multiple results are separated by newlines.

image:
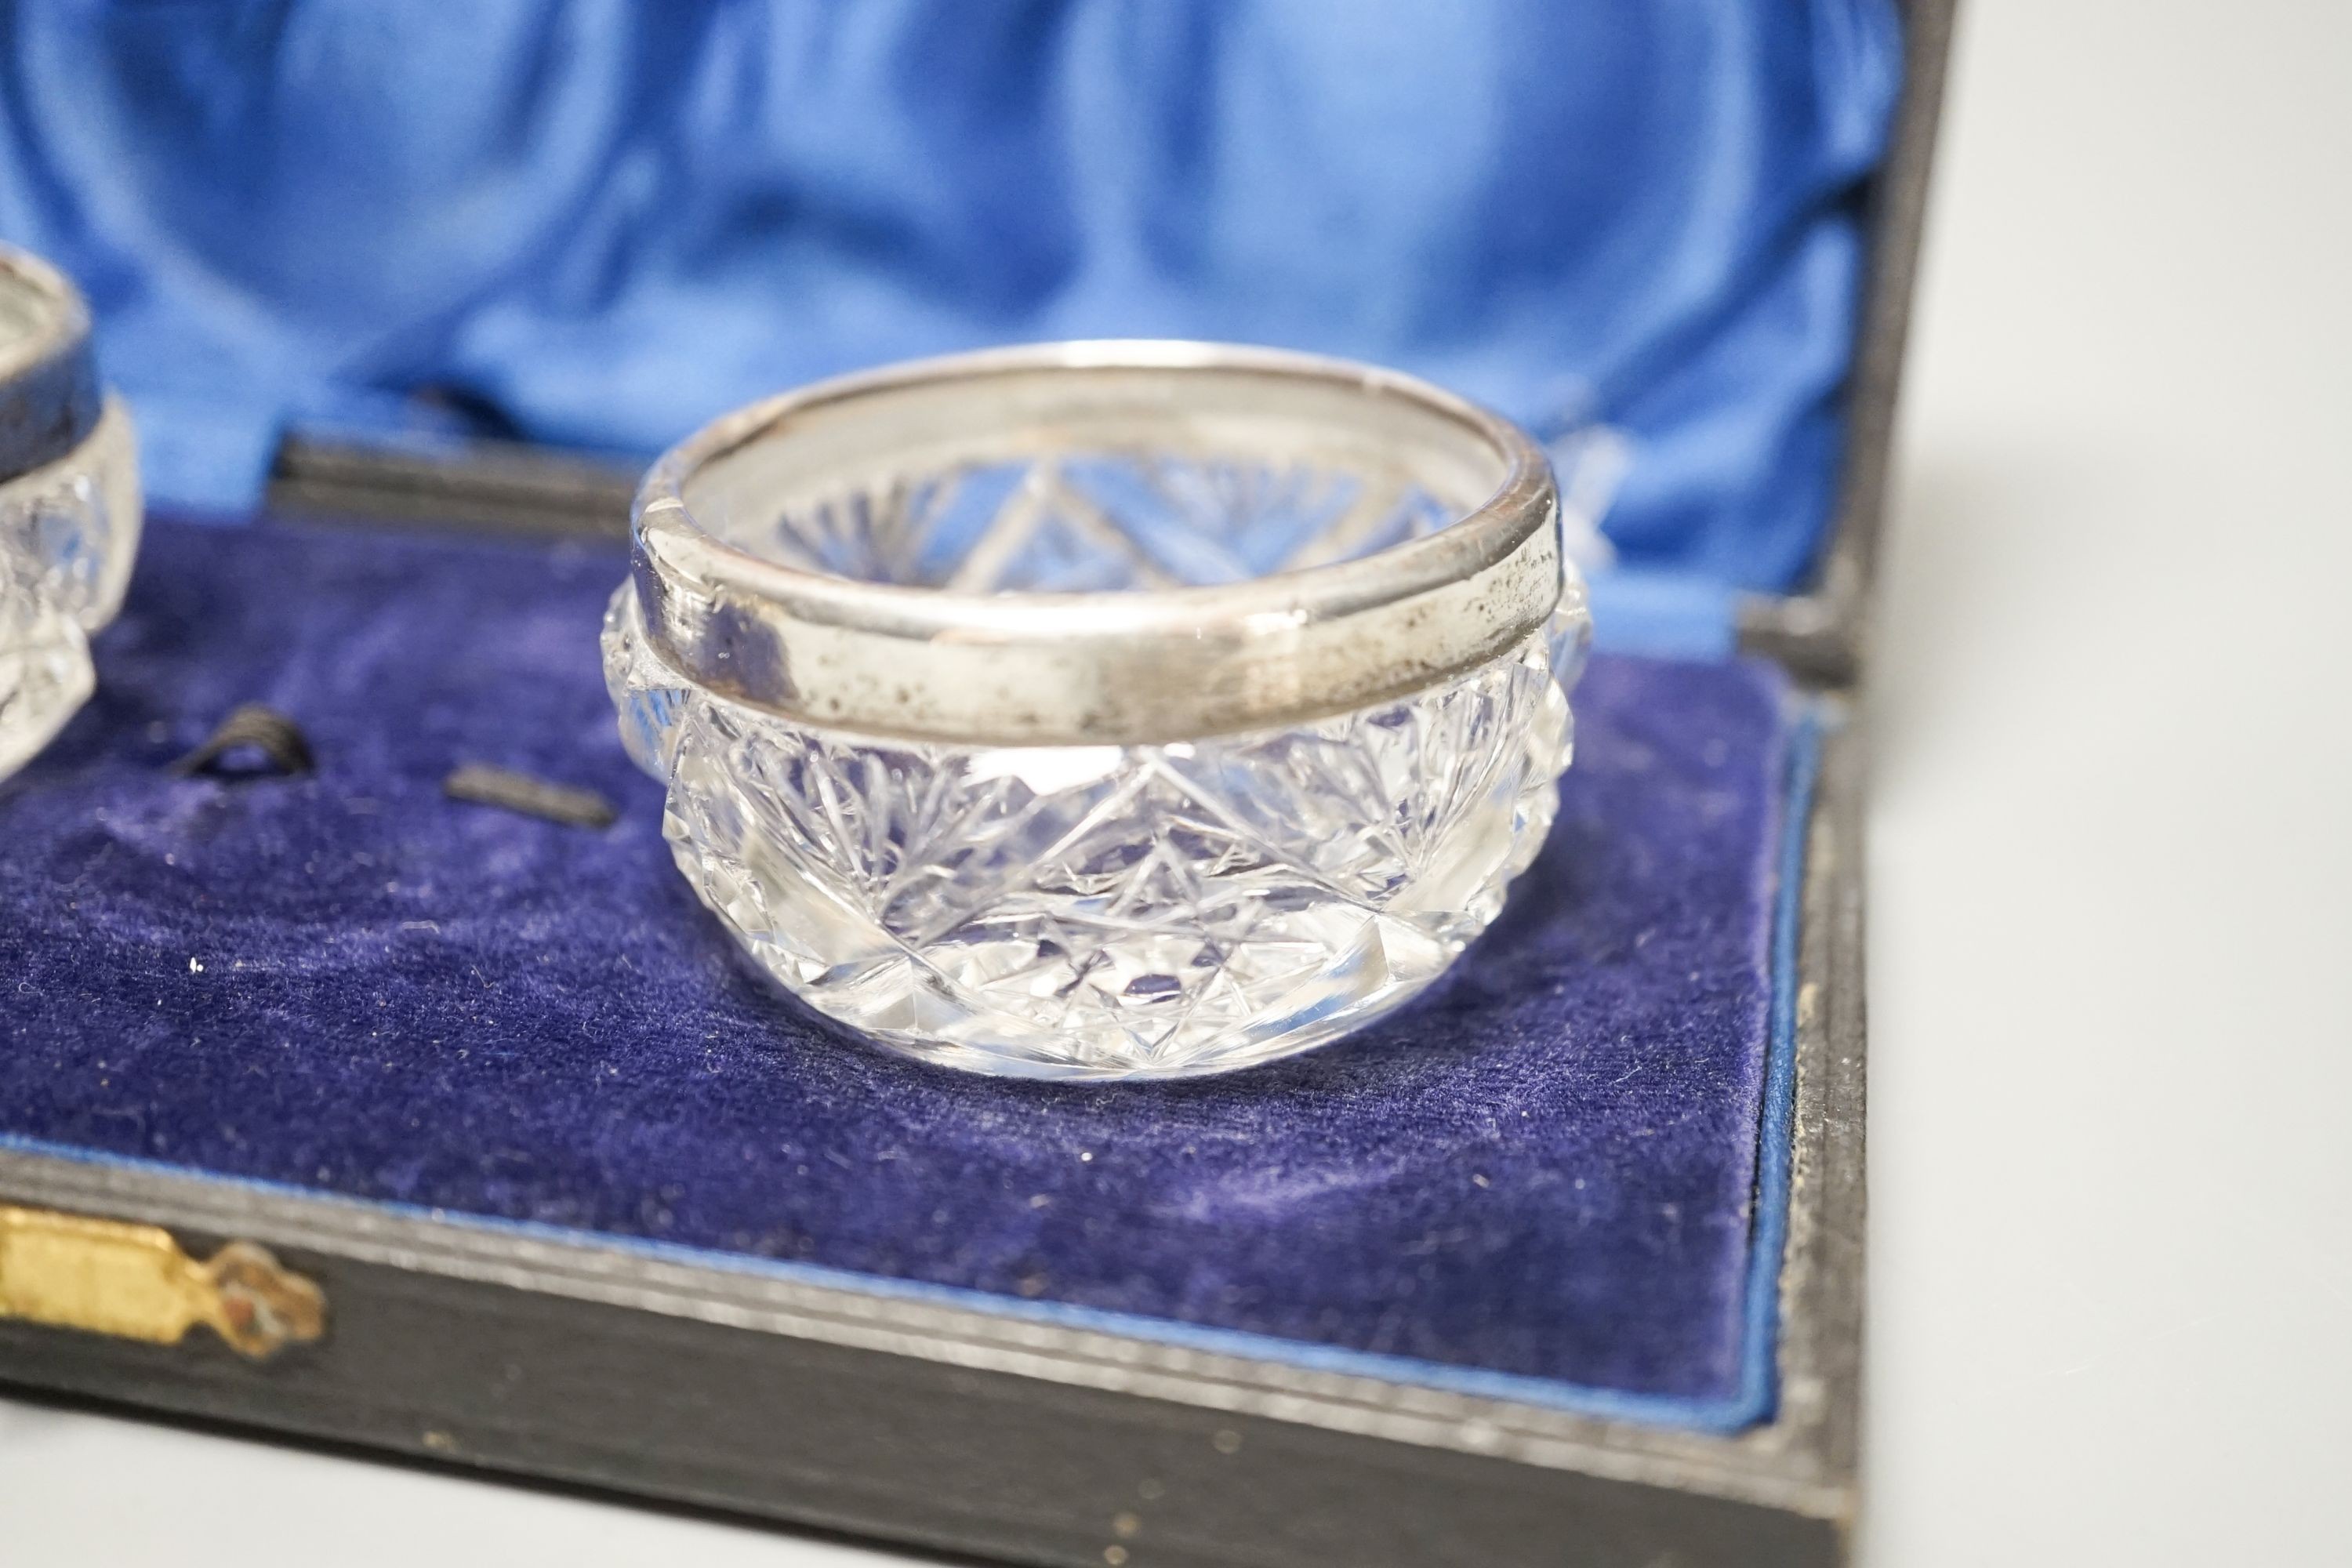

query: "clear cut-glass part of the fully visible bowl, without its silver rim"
xmin=604 ymin=441 xmax=1583 ymax=1076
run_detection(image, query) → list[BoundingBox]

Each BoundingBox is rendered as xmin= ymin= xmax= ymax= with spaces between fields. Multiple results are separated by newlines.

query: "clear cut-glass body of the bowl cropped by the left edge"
xmin=0 ymin=409 xmax=139 ymax=779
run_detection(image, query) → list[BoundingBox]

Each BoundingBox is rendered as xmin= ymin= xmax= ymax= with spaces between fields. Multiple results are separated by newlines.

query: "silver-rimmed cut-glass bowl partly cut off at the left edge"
xmin=0 ymin=247 xmax=141 ymax=779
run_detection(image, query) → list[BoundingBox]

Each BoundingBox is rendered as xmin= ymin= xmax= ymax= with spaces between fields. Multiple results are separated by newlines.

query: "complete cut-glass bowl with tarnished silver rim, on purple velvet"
xmin=604 ymin=343 xmax=1588 ymax=1079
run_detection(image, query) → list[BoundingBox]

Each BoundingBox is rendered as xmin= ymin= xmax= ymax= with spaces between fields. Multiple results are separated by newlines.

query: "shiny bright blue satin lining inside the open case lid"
xmin=0 ymin=0 xmax=1903 ymax=667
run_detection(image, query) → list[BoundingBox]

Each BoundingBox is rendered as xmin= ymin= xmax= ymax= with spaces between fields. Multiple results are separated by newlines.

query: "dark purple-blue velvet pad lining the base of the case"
xmin=0 ymin=522 xmax=1811 ymax=1429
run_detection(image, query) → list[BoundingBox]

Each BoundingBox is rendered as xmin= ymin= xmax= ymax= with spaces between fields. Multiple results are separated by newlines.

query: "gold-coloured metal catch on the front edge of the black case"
xmin=0 ymin=1203 xmax=327 ymax=1361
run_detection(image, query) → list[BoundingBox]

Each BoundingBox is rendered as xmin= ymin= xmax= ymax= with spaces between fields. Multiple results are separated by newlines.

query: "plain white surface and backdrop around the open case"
xmin=0 ymin=0 xmax=2352 ymax=1568
